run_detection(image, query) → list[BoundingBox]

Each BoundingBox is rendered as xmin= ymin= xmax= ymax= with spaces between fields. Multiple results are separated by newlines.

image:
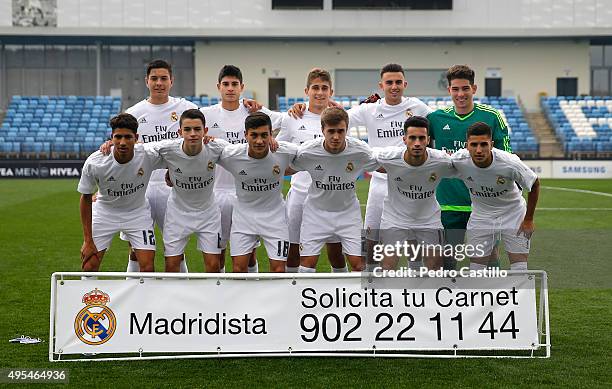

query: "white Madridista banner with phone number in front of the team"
xmin=52 ymin=274 xmax=539 ymax=354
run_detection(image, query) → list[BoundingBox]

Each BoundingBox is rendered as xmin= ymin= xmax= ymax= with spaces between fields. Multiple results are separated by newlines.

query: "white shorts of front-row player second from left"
xmin=164 ymin=201 xmax=221 ymax=256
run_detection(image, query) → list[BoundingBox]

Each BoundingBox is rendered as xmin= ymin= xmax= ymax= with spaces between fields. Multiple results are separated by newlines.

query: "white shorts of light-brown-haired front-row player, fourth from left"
xmin=300 ymin=200 xmax=362 ymax=257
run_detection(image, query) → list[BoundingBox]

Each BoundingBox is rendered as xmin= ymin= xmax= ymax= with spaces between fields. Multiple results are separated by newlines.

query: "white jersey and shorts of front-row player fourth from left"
xmin=293 ymin=137 xmax=378 ymax=256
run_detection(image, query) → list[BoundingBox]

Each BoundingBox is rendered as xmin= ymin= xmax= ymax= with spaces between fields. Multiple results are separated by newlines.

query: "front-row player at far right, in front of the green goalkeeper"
xmin=452 ymin=122 xmax=540 ymax=270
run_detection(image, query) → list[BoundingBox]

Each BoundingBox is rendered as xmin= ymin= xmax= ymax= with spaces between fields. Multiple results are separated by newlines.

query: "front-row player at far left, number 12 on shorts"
xmin=78 ymin=113 xmax=163 ymax=272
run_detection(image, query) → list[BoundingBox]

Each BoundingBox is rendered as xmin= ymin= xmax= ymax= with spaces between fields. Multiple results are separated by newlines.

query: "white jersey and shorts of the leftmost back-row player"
xmin=125 ymin=96 xmax=198 ymax=231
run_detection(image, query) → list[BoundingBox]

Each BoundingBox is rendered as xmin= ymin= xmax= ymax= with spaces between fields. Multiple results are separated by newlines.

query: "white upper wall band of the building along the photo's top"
xmin=0 ymin=0 xmax=612 ymax=37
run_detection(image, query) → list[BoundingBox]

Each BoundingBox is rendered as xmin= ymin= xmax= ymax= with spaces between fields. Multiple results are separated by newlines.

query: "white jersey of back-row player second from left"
xmin=200 ymin=100 xmax=282 ymax=191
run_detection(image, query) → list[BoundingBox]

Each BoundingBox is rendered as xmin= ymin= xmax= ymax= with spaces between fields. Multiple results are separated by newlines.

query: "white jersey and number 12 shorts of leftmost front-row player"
xmin=78 ymin=144 xmax=164 ymax=251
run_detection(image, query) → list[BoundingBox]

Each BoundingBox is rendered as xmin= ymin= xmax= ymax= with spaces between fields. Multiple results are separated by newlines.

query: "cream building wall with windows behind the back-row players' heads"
xmin=195 ymin=40 xmax=590 ymax=110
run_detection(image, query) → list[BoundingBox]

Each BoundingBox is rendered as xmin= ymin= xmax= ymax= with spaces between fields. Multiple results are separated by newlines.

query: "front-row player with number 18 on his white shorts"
xmin=218 ymin=112 xmax=298 ymax=273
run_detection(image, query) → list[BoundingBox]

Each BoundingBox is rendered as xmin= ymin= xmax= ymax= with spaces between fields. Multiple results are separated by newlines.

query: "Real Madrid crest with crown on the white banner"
xmin=74 ymin=288 xmax=117 ymax=346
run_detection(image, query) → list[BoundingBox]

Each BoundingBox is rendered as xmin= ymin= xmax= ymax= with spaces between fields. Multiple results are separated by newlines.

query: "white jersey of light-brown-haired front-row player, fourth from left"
xmin=293 ymin=137 xmax=378 ymax=211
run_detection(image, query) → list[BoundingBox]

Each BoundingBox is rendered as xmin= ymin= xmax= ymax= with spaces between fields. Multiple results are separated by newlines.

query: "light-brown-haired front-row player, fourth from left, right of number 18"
xmin=293 ymin=107 xmax=378 ymax=273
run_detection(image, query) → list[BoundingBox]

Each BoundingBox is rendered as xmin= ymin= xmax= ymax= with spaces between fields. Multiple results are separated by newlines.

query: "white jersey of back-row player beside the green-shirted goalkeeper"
xmin=348 ymin=97 xmax=432 ymax=147
